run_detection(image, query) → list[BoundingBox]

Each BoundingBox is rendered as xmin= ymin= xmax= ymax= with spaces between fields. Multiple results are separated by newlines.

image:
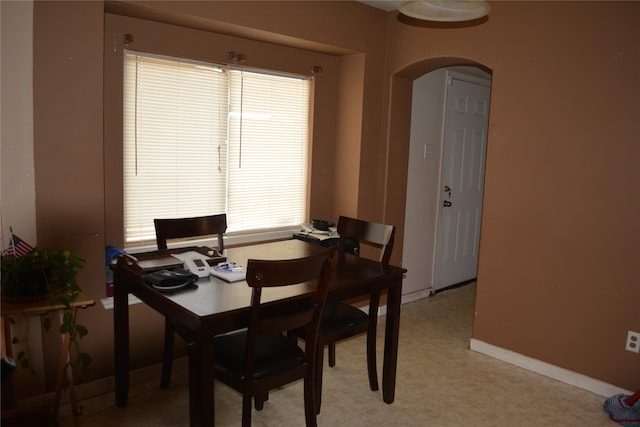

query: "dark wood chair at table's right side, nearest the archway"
xmin=290 ymin=216 xmax=395 ymax=413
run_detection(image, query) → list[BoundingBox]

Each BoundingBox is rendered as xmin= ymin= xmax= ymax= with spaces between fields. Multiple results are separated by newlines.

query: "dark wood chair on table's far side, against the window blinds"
xmin=153 ymin=214 xmax=227 ymax=388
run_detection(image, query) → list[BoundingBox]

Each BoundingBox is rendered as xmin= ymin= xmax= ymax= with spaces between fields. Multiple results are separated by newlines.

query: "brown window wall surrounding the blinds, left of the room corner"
xmin=34 ymin=1 xmax=386 ymax=384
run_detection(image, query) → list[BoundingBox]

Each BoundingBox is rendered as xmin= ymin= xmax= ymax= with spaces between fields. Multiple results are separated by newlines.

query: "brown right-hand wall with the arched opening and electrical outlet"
xmin=388 ymin=2 xmax=640 ymax=390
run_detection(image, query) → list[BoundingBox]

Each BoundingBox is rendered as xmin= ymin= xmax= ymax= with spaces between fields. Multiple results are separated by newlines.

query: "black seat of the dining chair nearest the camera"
xmin=215 ymin=330 xmax=305 ymax=379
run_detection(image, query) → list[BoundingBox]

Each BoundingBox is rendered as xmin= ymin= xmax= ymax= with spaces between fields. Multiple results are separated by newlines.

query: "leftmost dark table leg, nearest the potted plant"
xmin=113 ymin=272 xmax=129 ymax=408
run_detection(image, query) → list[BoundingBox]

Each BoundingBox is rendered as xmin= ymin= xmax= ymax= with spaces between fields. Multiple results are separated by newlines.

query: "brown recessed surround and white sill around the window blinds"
xmin=104 ymin=13 xmax=336 ymax=252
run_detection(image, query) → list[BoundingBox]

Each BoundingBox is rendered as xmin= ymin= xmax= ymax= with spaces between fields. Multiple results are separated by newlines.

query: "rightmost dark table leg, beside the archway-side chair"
xmin=382 ymin=276 xmax=402 ymax=403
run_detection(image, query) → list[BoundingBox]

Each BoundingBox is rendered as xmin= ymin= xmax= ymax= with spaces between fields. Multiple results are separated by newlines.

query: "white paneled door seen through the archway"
xmin=434 ymin=74 xmax=491 ymax=290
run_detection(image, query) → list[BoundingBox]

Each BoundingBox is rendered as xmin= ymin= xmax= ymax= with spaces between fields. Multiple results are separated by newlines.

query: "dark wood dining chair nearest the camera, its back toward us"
xmin=214 ymin=248 xmax=334 ymax=427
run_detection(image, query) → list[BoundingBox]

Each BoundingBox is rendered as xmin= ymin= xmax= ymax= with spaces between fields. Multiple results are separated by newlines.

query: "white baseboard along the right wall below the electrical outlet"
xmin=469 ymin=338 xmax=632 ymax=397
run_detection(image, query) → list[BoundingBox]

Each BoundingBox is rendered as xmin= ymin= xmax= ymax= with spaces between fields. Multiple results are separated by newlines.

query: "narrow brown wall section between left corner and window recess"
xmin=33 ymin=3 xmax=107 ymax=388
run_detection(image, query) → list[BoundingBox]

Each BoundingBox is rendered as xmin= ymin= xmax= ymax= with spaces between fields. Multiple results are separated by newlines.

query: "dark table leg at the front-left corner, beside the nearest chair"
xmin=187 ymin=330 xmax=215 ymax=427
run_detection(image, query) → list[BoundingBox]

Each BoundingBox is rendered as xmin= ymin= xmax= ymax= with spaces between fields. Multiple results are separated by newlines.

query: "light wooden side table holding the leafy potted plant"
xmin=0 ymin=293 xmax=95 ymax=426
